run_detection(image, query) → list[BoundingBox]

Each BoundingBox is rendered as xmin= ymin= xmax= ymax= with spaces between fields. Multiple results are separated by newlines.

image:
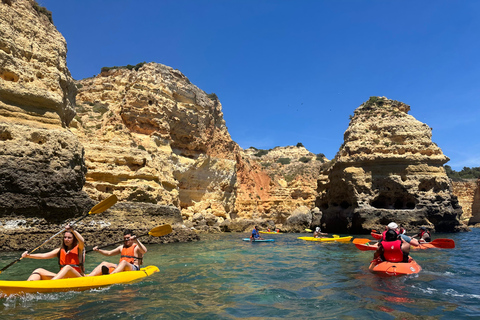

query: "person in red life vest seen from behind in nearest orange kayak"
xmin=373 ymin=229 xmax=410 ymax=262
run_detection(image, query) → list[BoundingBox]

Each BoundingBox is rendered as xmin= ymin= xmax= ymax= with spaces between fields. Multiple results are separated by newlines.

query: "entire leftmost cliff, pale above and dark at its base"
xmin=0 ymin=0 xmax=93 ymax=222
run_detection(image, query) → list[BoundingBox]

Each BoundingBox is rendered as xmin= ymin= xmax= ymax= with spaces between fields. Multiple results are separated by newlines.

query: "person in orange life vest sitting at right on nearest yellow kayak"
xmin=88 ymin=230 xmax=147 ymax=276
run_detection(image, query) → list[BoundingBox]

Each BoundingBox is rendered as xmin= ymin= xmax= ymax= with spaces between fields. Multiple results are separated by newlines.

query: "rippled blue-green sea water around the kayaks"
xmin=0 ymin=229 xmax=480 ymax=319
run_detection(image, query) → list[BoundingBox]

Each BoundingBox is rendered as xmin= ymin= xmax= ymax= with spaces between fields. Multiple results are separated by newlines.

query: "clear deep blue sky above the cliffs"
xmin=42 ymin=0 xmax=480 ymax=170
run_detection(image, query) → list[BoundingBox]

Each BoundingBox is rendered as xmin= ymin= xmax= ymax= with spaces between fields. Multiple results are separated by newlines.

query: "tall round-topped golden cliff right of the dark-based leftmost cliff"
xmin=71 ymin=63 xmax=240 ymax=222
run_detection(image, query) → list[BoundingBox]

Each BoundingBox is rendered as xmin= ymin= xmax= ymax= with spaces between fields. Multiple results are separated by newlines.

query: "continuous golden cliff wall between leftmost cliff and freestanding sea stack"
xmin=71 ymin=63 xmax=325 ymax=231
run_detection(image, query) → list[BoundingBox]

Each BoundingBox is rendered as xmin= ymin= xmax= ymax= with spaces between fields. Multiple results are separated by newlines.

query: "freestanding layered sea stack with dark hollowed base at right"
xmin=316 ymin=97 xmax=464 ymax=233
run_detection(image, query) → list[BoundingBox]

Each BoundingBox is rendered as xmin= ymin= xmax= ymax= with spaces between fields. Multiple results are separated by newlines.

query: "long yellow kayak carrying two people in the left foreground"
xmin=0 ymin=266 xmax=160 ymax=297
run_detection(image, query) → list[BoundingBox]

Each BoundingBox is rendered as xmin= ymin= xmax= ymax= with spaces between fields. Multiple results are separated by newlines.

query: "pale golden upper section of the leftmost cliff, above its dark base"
xmin=0 ymin=0 xmax=76 ymax=127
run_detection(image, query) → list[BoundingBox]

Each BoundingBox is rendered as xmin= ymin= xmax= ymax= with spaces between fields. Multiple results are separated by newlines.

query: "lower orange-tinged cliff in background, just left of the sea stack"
xmin=236 ymin=145 xmax=327 ymax=225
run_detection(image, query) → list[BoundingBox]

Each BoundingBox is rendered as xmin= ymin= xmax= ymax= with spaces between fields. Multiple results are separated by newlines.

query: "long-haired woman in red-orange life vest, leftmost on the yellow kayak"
xmin=22 ymin=225 xmax=85 ymax=281
